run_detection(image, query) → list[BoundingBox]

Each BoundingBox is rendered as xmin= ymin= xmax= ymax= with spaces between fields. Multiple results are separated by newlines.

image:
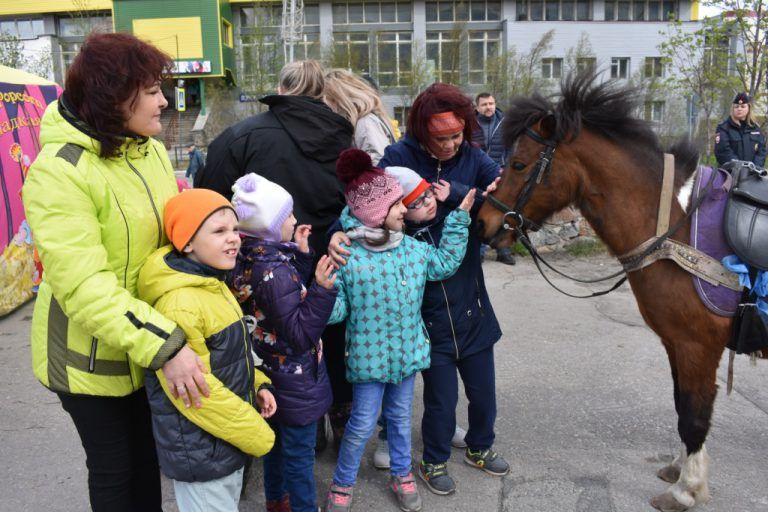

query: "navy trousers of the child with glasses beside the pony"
xmin=421 ymin=346 xmax=496 ymax=464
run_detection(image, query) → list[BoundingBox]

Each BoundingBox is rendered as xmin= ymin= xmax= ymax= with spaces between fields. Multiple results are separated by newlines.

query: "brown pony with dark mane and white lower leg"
xmin=478 ymin=75 xmax=732 ymax=511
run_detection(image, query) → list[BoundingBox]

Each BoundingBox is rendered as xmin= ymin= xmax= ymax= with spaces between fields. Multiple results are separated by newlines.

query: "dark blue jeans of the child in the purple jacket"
xmin=263 ymin=421 xmax=317 ymax=512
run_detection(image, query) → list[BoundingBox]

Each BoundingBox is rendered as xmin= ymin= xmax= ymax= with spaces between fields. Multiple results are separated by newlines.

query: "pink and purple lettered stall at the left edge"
xmin=0 ymin=66 xmax=61 ymax=317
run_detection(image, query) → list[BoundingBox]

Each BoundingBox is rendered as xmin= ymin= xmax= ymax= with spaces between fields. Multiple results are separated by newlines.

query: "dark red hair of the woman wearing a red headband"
xmin=407 ymin=83 xmax=477 ymax=144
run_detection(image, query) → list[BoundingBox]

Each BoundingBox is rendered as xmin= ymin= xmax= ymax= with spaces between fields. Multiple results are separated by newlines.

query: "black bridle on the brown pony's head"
xmin=486 ymin=127 xmax=558 ymax=245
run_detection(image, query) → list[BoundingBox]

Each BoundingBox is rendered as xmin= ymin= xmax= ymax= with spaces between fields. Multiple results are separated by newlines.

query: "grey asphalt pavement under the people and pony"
xmin=0 ymin=254 xmax=768 ymax=512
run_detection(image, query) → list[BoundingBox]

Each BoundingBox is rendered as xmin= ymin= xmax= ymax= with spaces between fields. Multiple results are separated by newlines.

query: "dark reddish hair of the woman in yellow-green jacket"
xmin=63 ymin=33 xmax=172 ymax=158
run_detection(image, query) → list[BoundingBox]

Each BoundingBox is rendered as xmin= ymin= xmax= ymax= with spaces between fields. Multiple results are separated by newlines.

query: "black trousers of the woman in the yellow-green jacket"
xmin=58 ymin=389 xmax=162 ymax=512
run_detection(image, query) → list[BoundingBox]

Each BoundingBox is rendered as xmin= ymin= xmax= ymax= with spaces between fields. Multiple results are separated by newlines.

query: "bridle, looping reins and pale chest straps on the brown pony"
xmin=486 ymin=127 xmax=741 ymax=299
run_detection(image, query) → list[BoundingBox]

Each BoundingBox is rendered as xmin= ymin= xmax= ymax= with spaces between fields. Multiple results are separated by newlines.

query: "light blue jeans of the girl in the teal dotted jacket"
xmin=333 ymin=374 xmax=416 ymax=486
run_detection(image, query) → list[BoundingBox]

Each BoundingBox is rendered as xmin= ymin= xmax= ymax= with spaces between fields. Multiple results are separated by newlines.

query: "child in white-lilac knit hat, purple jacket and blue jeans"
xmin=232 ymin=173 xmax=336 ymax=512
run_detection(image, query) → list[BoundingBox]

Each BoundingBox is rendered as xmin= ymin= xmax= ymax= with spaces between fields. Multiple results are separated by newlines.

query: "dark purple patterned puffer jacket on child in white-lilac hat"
xmin=228 ymin=236 xmax=336 ymax=425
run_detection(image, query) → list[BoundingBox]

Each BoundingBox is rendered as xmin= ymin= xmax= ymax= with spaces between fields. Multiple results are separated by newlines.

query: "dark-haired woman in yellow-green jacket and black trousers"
xmin=23 ymin=34 xmax=208 ymax=512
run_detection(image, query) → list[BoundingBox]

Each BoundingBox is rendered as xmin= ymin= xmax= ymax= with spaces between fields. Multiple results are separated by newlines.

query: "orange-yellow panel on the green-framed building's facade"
xmin=133 ymin=16 xmax=203 ymax=60
